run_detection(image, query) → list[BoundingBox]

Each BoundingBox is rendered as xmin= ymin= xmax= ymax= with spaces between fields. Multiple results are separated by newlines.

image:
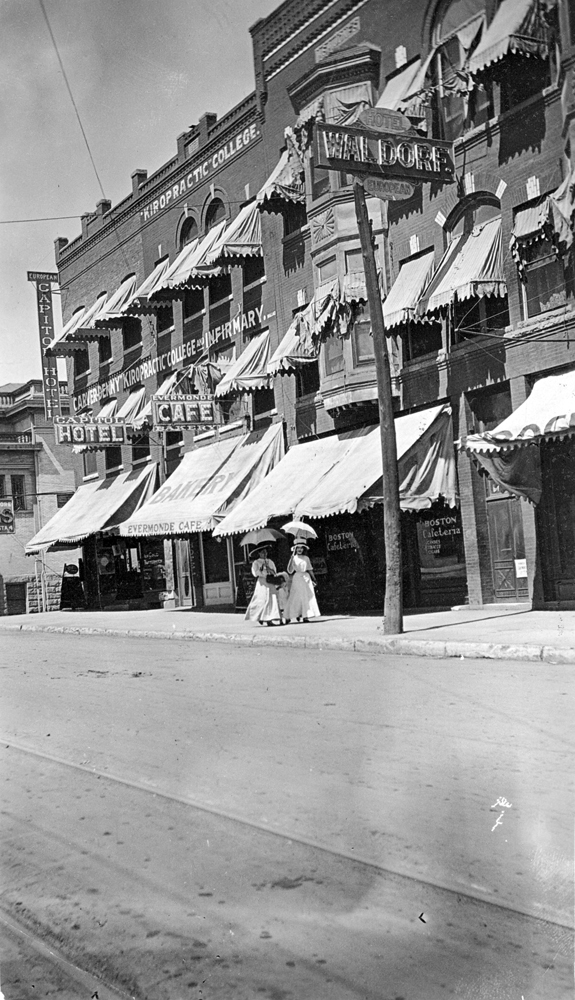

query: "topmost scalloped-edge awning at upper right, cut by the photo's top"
xmin=467 ymin=0 xmax=549 ymax=73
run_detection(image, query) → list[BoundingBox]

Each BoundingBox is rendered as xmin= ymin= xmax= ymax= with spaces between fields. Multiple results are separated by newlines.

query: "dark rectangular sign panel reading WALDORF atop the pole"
xmin=315 ymin=122 xmax=455 ymax=183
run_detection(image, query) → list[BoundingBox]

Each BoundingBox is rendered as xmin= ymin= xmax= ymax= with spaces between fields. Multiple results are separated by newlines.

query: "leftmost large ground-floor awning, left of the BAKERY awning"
xmin=26 ymin=463 xmax=157 ymax=555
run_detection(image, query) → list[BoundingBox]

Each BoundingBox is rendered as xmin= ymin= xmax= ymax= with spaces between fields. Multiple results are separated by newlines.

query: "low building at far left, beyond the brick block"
xmin=0 ymin=379 xmax=82 ymax=615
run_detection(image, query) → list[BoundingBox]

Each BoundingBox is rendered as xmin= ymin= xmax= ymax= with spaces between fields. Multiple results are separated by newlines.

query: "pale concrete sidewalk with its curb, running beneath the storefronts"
xmin=0 ymin=605 xmax=575 ymax=663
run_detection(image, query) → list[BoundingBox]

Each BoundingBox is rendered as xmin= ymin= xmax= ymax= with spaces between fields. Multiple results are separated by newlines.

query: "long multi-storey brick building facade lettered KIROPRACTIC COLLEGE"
xmin=33 ymin=0 xmax=575 ymax=609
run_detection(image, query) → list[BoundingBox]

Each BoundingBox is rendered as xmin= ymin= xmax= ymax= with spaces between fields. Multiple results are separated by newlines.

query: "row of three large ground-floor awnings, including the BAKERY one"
xmin=26 ymin=405 xmax=457 ymax=554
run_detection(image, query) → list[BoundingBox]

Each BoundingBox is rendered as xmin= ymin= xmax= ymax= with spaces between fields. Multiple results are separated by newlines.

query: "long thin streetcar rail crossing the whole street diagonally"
xmin=0 ymin=734 xmax=573 ymax=931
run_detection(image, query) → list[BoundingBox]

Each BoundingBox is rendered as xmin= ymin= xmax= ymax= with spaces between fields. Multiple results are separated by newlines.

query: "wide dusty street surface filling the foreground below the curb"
xmin=0 ymin=633 xmax=573 ymax=1000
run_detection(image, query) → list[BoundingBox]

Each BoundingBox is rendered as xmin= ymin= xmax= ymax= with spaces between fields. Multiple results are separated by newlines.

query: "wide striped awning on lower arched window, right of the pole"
xmin=416 ymin=219 xmax=507 ymax=318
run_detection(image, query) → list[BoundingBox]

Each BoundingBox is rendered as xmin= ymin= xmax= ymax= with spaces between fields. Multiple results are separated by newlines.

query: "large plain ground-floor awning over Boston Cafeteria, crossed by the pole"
xmin=214 ymin=405 xmax=457 ymax=535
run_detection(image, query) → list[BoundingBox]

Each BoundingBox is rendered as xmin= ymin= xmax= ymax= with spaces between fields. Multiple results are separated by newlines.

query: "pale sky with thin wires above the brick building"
xmin=0 ymin=0 xmax=279 ymax=385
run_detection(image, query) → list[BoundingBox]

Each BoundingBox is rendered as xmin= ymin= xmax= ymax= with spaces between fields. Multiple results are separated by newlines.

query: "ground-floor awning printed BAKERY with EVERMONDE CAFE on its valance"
xmin=120 ymin=423 xmax=284 ymax=536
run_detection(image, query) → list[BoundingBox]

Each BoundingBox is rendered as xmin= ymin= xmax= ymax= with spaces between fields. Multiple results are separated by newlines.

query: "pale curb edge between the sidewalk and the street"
xmin=0 ymin=622 xmax=575 ymax=664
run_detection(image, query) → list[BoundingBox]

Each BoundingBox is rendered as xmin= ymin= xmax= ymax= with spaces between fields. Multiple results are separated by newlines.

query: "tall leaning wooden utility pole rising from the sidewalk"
xmin=353 ymin=178 xmax=403 ymax=635
